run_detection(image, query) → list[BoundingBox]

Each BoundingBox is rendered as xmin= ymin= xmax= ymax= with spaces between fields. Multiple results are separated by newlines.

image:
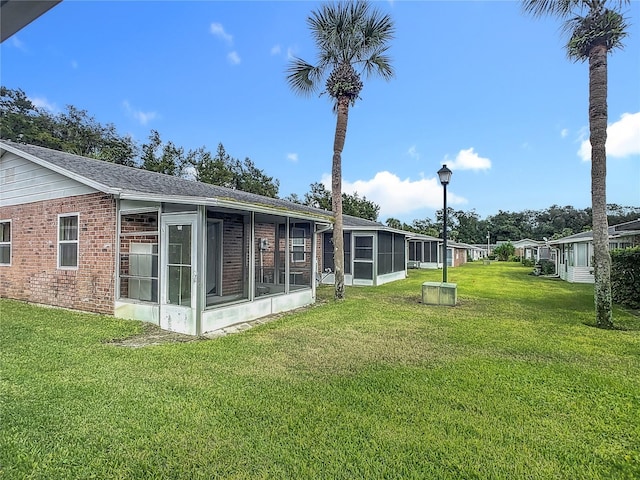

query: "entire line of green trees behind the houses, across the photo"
xmin=0 ymin=87 xmax=640 ymax=244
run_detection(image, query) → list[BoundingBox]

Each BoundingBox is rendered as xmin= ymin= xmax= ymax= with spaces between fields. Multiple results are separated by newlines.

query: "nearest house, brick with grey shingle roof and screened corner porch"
xmin=0 ymin=141 xmax=332 ymax=335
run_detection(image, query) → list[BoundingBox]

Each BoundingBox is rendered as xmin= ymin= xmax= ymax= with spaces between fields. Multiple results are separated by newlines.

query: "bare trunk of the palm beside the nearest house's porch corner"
xmin=331 ymin=97 xmax=349 ymax=300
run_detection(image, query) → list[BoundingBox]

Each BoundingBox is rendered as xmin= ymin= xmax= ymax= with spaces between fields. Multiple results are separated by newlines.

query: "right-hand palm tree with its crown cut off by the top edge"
xmin=523 ymin=0 xmax=629 ymax=328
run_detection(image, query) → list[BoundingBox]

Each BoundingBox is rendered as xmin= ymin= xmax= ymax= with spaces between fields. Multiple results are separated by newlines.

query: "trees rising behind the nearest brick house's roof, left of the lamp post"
xmin=0 ymin=86 xmax=380 ymax=215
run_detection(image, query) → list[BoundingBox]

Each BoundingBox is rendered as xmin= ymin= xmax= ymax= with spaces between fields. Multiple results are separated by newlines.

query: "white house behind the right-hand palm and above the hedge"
xmin=549 ymin=219 xmax=640 ymax=283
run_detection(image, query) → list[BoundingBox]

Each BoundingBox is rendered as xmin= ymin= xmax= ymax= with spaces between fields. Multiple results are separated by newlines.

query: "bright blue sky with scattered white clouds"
xmin=0 ymin=0 xmax=640 ymax=223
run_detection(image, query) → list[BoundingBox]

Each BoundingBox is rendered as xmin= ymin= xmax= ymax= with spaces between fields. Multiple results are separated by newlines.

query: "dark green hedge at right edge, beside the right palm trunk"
xmin=611 ymin=246 xmax=640 ymax=309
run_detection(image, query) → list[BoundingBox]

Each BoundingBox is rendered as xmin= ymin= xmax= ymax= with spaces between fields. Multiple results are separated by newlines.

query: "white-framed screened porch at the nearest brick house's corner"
xmin=115 ymin=200 xmax=326 ymax=335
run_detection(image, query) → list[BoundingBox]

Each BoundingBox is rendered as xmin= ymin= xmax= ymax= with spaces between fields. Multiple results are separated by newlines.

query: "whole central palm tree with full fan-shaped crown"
xmin=287 ymin=0 xmax=394 ymax=299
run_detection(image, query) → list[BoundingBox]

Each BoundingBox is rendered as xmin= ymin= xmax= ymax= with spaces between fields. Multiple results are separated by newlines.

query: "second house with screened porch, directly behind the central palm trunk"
xmin=318 ymin=215 xmax=410 ymax=285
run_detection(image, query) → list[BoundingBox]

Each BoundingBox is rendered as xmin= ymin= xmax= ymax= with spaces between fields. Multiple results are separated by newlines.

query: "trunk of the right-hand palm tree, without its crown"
xmin=589 ymin=45 xmax=613 ymax=328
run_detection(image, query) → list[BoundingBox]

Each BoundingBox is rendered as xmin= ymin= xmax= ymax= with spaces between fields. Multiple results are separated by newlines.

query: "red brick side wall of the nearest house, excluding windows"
xmin=0 ymin=193 xmax=116 ymax=313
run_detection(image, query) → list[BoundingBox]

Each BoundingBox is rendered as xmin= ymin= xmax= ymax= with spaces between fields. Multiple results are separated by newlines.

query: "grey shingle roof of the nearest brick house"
xmin=0 ymin=140 xmax=333 ymax=220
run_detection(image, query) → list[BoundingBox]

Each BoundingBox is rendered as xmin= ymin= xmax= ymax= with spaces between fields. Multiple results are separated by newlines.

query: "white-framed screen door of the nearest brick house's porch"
xmin=160 ymin=215 xmax=198 ymax=335
